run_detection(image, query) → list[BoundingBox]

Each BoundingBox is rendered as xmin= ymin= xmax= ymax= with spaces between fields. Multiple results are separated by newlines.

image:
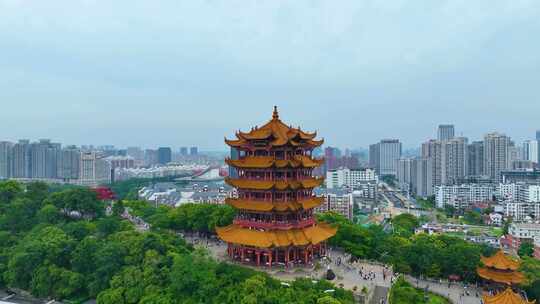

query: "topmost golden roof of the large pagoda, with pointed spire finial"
xmin=225 ymin=107 xmax=323 ymax=147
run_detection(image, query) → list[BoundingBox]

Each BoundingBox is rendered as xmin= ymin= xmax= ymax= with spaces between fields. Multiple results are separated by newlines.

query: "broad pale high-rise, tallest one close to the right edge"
xmin=484 ymin=133 xmax=511 ymax=182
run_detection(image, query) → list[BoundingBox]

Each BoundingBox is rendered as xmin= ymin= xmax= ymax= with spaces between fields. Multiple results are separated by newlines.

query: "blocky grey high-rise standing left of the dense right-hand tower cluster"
xmin=369 ymin=139 xmax=402 ymax=176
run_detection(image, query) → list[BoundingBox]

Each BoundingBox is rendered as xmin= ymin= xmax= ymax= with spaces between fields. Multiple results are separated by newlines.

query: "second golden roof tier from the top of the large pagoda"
xmin=225 ymin=155 xmax=324 ymax=169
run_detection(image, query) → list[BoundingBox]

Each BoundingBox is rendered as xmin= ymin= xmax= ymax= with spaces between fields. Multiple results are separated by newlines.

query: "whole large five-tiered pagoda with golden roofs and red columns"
xmin=216 ymin=107 xmax=337 ymax=267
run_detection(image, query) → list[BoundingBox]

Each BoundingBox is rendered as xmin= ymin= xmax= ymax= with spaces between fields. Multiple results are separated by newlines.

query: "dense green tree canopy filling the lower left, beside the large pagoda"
xmin=0 ymin=181 xmax=353 ymax=304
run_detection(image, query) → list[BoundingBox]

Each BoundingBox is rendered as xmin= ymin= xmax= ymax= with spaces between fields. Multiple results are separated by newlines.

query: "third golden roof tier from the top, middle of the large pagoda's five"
xmin=225 ymin=177 xmax=324 ymax=190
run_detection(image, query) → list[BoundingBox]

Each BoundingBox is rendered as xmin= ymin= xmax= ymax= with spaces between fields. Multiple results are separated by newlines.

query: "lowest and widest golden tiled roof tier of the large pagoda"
xmin=216 ymin=223 xmax=337 ymax=248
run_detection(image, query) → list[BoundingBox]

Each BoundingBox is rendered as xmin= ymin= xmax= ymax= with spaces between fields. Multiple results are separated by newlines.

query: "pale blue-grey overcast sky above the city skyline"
xmin=0 ymin=0 xmax=540 ymax=150
